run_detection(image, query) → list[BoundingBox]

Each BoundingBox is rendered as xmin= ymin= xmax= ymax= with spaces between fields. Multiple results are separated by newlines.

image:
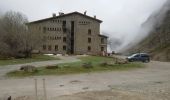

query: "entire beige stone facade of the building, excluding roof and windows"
xmin=29 ymin=14 xmax=107 ymax=55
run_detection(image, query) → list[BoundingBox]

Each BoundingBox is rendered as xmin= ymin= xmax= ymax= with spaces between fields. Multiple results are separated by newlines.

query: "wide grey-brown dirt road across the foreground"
xmin=0 ymin=61 xmax=170 ymax=100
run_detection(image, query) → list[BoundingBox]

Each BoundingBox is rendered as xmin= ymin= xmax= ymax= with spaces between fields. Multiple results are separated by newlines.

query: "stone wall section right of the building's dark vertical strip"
xmin=75 ymin=16 xmax=100 ymax=54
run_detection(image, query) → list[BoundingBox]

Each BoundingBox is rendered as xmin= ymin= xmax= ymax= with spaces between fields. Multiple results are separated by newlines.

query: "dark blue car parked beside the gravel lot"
xmin=126 ymin=53 xmax=150 ymax=62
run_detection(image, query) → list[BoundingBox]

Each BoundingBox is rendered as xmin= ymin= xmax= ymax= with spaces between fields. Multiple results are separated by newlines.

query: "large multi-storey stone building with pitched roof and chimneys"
xmin=28 ymin=12 xmax=107 ymax=55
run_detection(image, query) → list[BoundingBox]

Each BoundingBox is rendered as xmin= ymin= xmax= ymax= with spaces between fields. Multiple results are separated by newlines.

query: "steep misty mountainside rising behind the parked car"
xmin=129 ymin=1 xmax=170 ymax=61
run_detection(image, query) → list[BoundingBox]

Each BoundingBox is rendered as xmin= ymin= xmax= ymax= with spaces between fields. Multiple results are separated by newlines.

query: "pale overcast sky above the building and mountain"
xmin=0 ymin=0 xmax=166 ymax=51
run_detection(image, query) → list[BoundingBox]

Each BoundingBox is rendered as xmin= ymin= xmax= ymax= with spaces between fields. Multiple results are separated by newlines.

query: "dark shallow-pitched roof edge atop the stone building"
xmin=28 ymin=12 xmax=102 ymax=24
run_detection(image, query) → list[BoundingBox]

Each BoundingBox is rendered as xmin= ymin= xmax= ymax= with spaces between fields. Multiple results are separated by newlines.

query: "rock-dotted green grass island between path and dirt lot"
xmin=7 ymin=56 xmax=144 ymax=77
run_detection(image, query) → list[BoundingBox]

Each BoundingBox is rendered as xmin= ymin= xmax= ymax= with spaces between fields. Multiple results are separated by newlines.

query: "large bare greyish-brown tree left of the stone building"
xmin=0 ymin=11 xmax=41 ymax=58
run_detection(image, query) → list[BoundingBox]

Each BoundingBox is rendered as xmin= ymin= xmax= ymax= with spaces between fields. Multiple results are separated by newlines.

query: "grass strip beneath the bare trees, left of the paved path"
xmin=0 ymin=55 xmax=58 ymax=66
